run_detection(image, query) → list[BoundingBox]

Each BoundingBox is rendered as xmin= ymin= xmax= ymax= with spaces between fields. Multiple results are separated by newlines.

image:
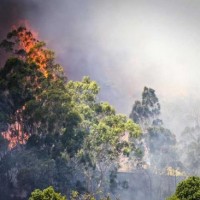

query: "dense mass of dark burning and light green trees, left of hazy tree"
xmin=0 ymin=27 xmax=141 ymax=200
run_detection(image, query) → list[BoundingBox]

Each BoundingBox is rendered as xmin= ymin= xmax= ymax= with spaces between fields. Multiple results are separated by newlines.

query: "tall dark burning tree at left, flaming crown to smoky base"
xmin=0 ymin=27 xmax=76 ymax=199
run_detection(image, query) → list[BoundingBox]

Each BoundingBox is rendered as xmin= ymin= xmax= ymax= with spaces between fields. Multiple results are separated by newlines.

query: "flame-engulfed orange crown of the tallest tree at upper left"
xmin=0 ymin=27 xmax=53 ymax=77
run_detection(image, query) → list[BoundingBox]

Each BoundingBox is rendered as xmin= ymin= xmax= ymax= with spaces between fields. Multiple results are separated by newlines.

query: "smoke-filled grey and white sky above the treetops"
xmin=0 ymin=0 xmax=200 ymax=134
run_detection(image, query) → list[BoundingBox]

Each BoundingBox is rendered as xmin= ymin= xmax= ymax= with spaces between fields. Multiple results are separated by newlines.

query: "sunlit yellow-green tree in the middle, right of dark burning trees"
xmin=67 ymin=77 xmax=141 ymax=192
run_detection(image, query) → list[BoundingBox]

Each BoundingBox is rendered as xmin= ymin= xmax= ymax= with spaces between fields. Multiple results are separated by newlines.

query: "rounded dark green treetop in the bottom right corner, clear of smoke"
xmin=167 ymin=176 xmax=200 ymax=200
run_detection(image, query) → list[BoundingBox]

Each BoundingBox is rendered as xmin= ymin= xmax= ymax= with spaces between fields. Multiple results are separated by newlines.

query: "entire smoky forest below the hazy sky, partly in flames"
xmin=0 ymin=26 xmax=200 ymax=200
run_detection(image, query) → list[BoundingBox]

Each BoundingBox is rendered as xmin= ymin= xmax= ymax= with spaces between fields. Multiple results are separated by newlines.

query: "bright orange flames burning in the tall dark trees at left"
xmin=1 ymin=21 xmax=51 ymax=149
